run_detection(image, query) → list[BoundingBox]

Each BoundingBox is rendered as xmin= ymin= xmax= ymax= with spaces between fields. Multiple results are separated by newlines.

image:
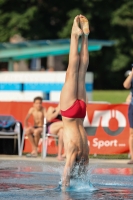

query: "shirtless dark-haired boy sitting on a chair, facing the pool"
xmin=24 ymin=97 xmax=46 ymax=157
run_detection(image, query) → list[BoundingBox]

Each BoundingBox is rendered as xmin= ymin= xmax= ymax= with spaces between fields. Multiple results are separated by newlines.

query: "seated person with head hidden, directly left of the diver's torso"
xmin=46 ymin=105 xmax=65 ymax=161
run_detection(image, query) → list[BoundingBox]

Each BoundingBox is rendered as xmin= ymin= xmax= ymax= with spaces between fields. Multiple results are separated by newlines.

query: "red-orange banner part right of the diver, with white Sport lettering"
xmin=84 ymin=104 xmax=129 ymax=154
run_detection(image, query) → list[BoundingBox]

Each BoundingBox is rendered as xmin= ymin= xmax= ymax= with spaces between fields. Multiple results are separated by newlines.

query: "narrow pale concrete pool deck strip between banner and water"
xmin=0 ymin=155 xmax=133 ymax=168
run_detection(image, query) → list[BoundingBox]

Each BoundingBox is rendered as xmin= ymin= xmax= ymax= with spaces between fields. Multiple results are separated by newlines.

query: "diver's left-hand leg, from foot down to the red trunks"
xmin=60 ymin=16 xmax=82 ymax=110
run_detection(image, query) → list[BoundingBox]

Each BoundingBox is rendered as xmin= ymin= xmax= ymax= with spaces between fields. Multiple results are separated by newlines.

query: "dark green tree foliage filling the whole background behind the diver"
xmin=0 ymin=0 xmax=133 ymax=89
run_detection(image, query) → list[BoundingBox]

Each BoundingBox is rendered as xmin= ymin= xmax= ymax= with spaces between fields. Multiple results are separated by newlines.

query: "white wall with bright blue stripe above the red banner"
xmin=0 ymin=71 xmax=93 ymax=101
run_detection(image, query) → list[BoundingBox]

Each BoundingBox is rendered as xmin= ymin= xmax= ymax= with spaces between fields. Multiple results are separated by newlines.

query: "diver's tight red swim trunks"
xmin=61 ymin=99 xmax=86 ymax=118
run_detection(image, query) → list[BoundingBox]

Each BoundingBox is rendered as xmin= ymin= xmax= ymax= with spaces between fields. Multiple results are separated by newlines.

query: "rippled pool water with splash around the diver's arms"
xmin=0 ymin=161 xmax=133 ymax=200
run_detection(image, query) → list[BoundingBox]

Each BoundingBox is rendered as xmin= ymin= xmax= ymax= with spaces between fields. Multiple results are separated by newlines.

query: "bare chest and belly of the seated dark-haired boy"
xmin=32 ymin=107 xmax=44 ymax=127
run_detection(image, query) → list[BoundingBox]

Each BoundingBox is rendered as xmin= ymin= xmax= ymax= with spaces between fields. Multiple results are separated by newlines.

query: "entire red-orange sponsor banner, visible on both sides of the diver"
xmin=0 ymin=102 xmax=129 ymax=154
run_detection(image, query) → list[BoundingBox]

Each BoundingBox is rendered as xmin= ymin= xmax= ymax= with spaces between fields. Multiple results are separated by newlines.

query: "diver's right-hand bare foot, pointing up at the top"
xmin=79 ymin=15 xmax=90 ymax=35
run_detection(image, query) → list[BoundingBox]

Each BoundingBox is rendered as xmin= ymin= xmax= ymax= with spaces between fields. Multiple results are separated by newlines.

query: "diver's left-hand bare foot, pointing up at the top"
xmin=72 ymin=15 xmax=83 ymax=36
